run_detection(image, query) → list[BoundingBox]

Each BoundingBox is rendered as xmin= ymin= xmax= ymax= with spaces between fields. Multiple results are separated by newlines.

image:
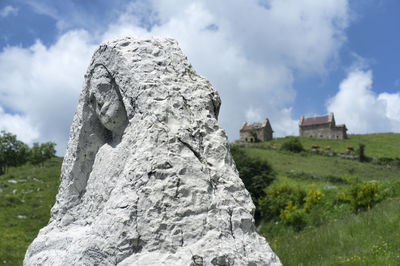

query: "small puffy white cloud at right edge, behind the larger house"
xmin=327 ymin=69 xmax=400 ymax=133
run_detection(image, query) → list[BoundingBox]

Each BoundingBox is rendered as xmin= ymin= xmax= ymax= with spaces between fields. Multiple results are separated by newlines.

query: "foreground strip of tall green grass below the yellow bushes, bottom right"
xmin=261 ymin=199 xmax=400 ymax=265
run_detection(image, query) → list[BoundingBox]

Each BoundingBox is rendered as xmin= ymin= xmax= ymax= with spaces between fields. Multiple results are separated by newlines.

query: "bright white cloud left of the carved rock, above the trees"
xmin=0 ymin=31 xmax=94 ymax=154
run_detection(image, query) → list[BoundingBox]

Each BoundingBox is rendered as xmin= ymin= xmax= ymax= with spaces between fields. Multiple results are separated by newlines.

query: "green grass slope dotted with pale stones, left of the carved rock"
xmin=0 ymin=158 xmax=62 ymax=265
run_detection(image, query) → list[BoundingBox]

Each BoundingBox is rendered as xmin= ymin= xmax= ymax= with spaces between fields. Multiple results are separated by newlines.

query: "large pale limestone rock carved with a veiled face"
xmin=24 ymin=38 xmax=280 ymax=266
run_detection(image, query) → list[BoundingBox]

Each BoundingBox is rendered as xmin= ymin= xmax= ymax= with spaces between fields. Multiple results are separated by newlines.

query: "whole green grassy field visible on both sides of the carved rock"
xmin=0 ymin=134 xmax=400 ymax=265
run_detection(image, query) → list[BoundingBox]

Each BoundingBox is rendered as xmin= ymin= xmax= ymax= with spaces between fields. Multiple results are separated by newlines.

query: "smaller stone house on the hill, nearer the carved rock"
xmin=240 ymin=119 xmax=274 ymax=142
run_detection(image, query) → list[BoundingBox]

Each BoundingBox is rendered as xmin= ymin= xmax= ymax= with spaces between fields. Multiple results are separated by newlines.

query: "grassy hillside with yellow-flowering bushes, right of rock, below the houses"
xmin=239 ymin=134 xmax=400 ymax=265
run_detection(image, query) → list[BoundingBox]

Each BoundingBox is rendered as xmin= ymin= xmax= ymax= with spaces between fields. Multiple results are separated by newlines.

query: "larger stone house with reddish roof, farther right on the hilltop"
xmin=299 ymin=113 xmax=347 ymax=139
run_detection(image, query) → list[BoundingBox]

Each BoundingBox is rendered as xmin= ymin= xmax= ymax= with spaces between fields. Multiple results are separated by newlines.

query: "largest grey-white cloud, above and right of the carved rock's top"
xmin=101 ymin=0 xmax=348 ymax=140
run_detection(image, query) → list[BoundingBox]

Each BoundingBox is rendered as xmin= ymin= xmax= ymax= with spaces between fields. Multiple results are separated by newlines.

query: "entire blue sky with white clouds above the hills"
xmin=0 ymin=0 xmax=400 ymax=155
